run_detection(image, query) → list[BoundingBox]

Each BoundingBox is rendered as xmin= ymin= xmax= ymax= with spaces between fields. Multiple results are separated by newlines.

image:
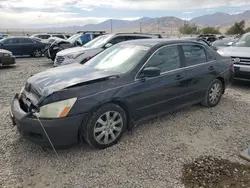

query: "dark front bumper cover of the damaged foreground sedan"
xmin=10 ymin=95 xmax=87 ymax=148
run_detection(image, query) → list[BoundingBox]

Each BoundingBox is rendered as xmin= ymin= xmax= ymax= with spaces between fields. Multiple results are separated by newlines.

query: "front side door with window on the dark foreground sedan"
xmin=129 ymin=45 xmax=186 ymax=120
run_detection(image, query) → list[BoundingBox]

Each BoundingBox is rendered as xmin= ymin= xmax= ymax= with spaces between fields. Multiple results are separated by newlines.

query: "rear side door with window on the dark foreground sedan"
xmin=182 ymin=44 xmax=216 ymax=102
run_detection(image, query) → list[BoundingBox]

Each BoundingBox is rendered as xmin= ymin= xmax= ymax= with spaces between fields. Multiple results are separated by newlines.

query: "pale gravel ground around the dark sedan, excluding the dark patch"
xmin=0 ymin=58 xmax=250 ymax=188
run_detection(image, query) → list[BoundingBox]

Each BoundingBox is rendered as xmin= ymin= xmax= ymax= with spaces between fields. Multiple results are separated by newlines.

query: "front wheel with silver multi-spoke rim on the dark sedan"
xmin=81 ymin=103 xmax=127 ymax=149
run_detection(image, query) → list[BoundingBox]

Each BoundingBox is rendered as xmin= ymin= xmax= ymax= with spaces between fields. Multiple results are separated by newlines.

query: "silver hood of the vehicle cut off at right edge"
xmin=217 ymin=46 xmax=250 ymax=57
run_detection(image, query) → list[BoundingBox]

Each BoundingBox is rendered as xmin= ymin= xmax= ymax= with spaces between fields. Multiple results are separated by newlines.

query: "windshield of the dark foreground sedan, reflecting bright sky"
xmin=83 ymin=44 xmax=150 ymax=74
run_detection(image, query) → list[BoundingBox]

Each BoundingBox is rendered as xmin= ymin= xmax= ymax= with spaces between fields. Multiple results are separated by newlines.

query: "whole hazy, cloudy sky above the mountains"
xmin=0 ymin=0 xmax=250 ymax=28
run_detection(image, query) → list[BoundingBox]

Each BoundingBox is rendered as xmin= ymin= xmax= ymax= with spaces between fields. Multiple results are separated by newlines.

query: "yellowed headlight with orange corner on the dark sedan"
xmin=38 ymin=98 xmax=77 ymax=118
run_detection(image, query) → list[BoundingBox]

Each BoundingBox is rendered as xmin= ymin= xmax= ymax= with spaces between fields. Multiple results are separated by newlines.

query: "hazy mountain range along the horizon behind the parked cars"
xmin=3 ymin=10 xmax=250 ymax=34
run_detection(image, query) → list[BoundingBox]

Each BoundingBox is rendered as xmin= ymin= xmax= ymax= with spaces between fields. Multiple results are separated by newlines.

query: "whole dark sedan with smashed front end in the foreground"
xmin=10 ymin=39 xmax=232 ymax=149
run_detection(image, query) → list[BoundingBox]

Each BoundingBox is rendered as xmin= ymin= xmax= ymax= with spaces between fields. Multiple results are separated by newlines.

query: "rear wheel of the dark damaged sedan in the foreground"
xmin=201 ymin=79 xmax=223 ymax=107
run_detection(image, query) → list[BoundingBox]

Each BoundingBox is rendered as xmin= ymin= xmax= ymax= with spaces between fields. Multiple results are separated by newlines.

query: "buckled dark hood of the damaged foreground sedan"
xmin=25 ymin=63 xmax=118 ymax=96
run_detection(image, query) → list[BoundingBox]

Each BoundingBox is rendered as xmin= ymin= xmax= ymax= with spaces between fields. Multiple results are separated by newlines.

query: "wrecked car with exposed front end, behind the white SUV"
xmin=45 ymin=31 xmax=105 ymax=61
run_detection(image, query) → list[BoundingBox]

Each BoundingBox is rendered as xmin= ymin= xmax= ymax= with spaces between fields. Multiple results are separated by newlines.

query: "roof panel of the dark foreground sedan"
xmin=124 ymin=39 xmax=208 ymax=47
